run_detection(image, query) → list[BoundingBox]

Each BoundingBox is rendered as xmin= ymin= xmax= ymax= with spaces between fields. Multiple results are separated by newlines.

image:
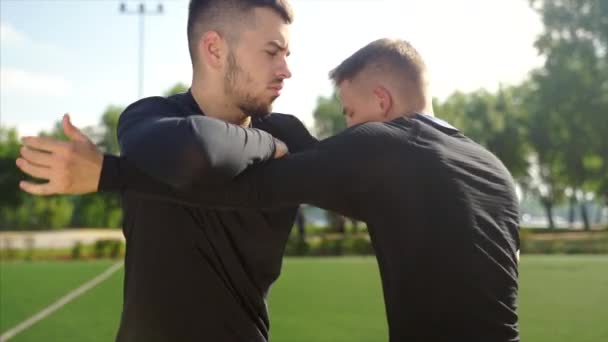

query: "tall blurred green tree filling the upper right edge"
xmin=530 ymin=0 xmax=608 ymax=229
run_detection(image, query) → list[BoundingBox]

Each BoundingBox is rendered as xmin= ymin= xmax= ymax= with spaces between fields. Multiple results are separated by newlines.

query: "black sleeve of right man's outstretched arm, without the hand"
xmin=99 ymin=124 xmax=384 ymax=219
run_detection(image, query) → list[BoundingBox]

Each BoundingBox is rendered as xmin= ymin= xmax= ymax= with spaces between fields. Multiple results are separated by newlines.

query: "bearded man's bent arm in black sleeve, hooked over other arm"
xmin=118 ymin=98 xmax=275 ymax=189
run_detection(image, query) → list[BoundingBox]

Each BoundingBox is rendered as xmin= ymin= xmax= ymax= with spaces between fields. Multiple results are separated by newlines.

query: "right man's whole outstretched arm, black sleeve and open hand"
xmin=18 ymin=111 xmax=390 ymax=219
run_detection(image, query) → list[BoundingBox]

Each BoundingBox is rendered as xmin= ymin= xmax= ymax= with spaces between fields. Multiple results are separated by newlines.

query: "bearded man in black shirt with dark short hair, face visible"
xmin=20 ymin=0 xmax=315 ymax=342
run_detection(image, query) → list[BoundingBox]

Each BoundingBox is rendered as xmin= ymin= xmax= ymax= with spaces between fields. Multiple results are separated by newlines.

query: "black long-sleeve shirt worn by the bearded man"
xmin=106 ymin=92 xmax=316 ymax=342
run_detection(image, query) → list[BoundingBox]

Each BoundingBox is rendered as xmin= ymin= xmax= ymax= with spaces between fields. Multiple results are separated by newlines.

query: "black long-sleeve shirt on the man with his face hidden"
xmin=102 ymin=111 xmax=519 ymax=342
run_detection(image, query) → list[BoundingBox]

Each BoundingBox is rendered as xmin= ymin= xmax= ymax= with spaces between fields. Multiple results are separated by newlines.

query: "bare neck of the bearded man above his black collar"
xmin=190 ymin=77 xmax=251 ymax=127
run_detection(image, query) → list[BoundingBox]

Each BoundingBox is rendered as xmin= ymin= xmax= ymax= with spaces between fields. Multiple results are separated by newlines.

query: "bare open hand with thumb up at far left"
xmin=17 ymin=114 xmax=103 ymax=195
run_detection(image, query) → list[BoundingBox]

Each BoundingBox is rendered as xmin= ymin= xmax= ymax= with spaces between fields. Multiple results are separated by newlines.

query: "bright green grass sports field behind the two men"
xmin=0 ymin=255 xmax=608 ymax=342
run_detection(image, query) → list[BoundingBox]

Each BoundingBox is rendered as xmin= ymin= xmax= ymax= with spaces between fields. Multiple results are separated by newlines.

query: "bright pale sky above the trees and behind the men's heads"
xmin=0 ymin=0 xmax=542 ymax=135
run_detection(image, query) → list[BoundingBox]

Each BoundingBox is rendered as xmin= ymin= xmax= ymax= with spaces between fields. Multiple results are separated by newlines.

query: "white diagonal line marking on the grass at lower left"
xmin=0 ymin=261 xmax=123 ymax=342
